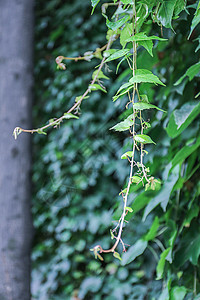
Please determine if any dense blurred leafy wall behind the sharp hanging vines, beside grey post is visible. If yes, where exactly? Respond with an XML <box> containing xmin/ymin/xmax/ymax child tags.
<box><xmin>32</xmin><ymin>0</ymin><xmax>200</xmax><ymax>300</ymax></box>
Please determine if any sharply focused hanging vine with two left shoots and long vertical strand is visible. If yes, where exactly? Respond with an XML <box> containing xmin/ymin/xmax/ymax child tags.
<box><xmin>13</xmin><ymin>0</ymin><xmax>169</xmax><ymax>260</ymax></box>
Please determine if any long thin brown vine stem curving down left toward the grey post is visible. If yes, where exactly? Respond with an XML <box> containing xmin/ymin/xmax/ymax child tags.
<box><xmin>14</xmin><ymin>34</ymin><xmax>115</xmax><ymax>133</ymax></box>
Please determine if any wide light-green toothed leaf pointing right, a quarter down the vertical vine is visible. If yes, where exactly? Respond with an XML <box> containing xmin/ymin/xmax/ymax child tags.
<box><xmin>129</xmin><ymin>69</ymin><xmax>165</xmax><ymax>86</ymax></box>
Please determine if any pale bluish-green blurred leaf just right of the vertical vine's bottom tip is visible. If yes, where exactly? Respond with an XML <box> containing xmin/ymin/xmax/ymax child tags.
<box><xmin>122</xmin><ymin>240</ymin><xmax>148</xmax><ymax>266</ymax></box>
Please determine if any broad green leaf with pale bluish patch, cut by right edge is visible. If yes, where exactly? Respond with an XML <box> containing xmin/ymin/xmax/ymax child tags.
<box><xmin>166</xmin><ymin>101</ymin><xmax>200</xmax><ymax>138</ymax></box>
